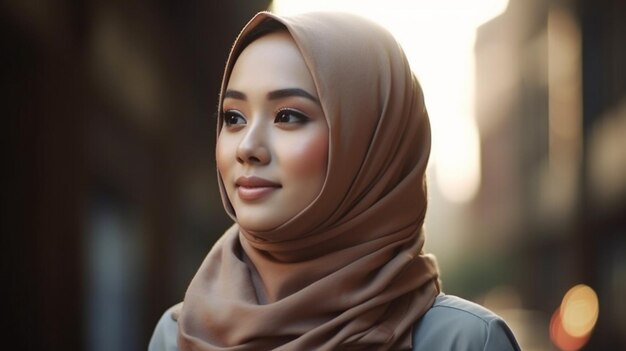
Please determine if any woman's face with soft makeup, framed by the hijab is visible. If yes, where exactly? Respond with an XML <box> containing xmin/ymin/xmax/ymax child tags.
<box><xmin>216</xmin><ymin>32</ymin><xmax>328</xmax><ymax>231</ymax></box>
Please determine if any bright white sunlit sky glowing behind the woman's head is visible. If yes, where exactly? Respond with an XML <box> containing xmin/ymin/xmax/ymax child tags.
<box><xmin>272</xmin><ymin>0</ymin><xmax>508</xmax><ymax>202</ymax></box>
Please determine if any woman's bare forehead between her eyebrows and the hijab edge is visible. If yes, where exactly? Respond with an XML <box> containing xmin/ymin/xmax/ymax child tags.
<box><xmin>228</xmin><ymin>31</ymin><xmax>317</xmax><ymax>95</ymax></box>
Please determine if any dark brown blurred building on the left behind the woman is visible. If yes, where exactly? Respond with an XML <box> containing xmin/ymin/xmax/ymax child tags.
<box><xmin>0</xmin><ymin>0</ymin><xmax>269</xmax><ymax>350</ymax></box>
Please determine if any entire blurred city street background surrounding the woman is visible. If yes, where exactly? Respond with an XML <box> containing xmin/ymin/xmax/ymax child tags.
<box><xmin>0</xmin><ymin>0</ymin><xmax>626</xmax><ymax>351</ymax></box>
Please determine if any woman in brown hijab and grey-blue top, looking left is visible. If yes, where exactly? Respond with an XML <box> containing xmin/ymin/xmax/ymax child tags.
<box><xmin>149</xmin><ymin>12</ymin><xmax>519</xmax><ymax>350</ymax></box>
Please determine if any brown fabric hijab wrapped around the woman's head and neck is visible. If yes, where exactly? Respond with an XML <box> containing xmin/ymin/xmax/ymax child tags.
<box><xmin>178</xmin><ymin>12</ymin><xmax>439</xmax><ymax>350</ymax></box>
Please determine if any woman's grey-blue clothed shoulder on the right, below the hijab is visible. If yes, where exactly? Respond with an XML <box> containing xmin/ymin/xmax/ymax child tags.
<box><xmin>413</xmin><ymin>295</ymin><xmax>520</xmax><ymax>351</ymax></box>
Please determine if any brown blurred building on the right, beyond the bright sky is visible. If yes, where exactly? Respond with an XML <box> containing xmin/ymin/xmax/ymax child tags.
<box><xmin>473</xmin><ymin>0</ymin><xmax>626</xmax><ymax>350</ymax></box>
